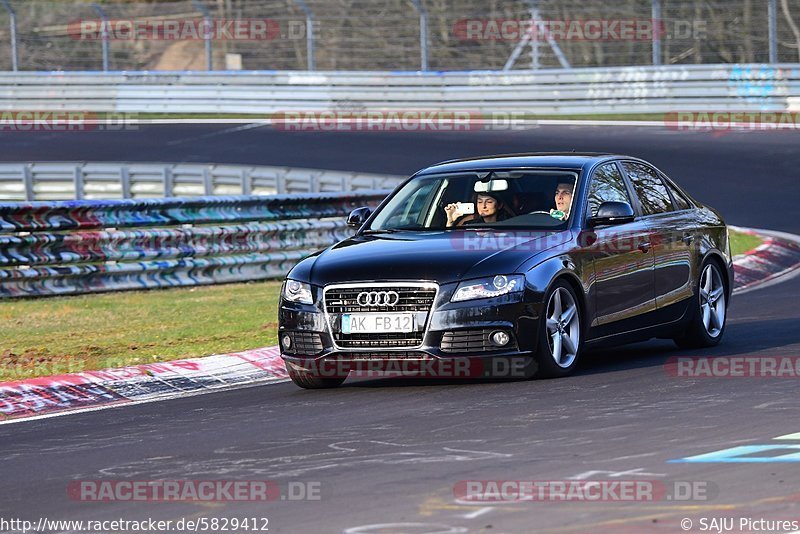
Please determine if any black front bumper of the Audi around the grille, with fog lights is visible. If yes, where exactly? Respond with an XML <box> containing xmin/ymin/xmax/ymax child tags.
<box><xmin>278</xmin><ymin>283</ymin><xmax>542</xmax><ymax>377</ymax></box>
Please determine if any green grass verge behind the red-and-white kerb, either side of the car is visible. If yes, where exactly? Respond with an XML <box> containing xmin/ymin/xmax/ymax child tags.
<box><xmin>0</xmin><ymin>228</ymin><xmax>761</xmax><ymax>381</ymax></box>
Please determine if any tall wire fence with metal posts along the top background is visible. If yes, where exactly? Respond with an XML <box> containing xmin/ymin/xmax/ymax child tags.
<box><xmin>0</xmin><ymin>0</ymin><xmax>800</xmax><ymax>71</ymax></box>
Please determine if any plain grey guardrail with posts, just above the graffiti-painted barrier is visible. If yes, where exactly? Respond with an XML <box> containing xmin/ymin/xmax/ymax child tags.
<box><xmin>0</xmin><ymin>162</ymin><xmax>405</xmax><ymax>200</ymax></box>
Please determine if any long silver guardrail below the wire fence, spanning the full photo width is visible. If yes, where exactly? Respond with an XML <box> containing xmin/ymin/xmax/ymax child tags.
<box><xmin>0</xmin><ymin>64</ymin><xmax>800</xmax><ymax>114</ymax></box>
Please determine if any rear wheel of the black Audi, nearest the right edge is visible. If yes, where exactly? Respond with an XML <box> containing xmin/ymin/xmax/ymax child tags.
<box><xmin>674</xmin><ymin>261</ymin><xmax>728</xmax><ymax>349</ymax></box>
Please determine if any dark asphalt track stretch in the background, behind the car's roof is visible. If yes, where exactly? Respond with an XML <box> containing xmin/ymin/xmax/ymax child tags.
<box><xmin>0</xmin><ymin>125</ymin><xmax>800</xmax><ymax>234</ymax></box>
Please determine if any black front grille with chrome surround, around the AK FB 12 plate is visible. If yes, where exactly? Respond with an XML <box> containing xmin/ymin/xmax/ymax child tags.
<box><xmin>325</xmin><ymin>284</ymin><xmax>436</xmax><ymax>350</ymax></box>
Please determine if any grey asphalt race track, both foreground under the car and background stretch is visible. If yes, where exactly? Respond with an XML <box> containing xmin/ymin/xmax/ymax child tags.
<box><xmin>0</xmin><ymin>125</ymin><xmax>800</xmax><ymax>533</ymax></box>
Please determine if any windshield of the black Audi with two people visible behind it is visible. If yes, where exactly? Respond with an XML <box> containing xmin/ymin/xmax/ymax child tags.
<box><xmin>367</xmin><ymin>170</ymin><xmax>578</xmax><ymax>232</ymax></box>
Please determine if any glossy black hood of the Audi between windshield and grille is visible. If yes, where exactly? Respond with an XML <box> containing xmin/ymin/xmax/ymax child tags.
<box><xmin>290</xmin><ymin>231</ymin><xmax>571</xmax><ymax>285</ymax></box>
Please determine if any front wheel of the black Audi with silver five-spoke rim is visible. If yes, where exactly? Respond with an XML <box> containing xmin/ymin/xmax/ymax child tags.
<box><xmin>534</xmin><ymin>280</ymin><xmax>583</xmax><ymax>378</ymax></box>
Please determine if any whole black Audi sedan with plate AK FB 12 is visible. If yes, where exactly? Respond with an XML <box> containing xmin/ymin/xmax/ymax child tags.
<box><xmin>278</xmin><ymin>153</ymin><xmax>733</xmax><ymax>388</ymax></box>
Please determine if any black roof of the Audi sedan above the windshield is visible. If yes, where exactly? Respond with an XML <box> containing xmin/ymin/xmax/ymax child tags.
<box><xmin>417</xmin><ymin>152</ymin><xmax>636</xmax><ymax>175</ymax></box>
